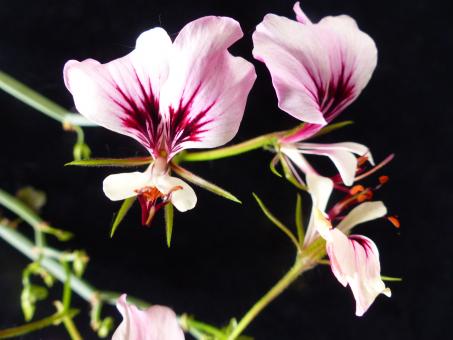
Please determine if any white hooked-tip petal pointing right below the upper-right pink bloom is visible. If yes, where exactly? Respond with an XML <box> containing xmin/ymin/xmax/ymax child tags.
<box><xmin>296</xmin><ymin>142</ymin><xmax>373</xmax><ymax>185</ymax></box>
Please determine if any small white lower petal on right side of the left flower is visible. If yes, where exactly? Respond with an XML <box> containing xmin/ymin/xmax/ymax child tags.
<box><xmin>156</xmin><ymin>175</ymin><xmax>197</xmax><ymax>212</ymax></box>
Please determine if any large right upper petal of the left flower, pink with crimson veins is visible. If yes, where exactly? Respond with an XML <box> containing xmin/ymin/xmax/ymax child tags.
<box><xmin>161</xmin><ymin>16</ymin><xmax>256</xmax><ymax>154</ymax></box>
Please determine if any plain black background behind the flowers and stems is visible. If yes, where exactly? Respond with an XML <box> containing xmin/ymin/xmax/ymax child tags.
<box><xmin>0</xmin><ymin>0</ymin><xmax>446</xmax><ymax>339</ymax></box>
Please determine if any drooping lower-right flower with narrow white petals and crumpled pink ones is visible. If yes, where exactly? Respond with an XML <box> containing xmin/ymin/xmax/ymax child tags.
<box><xmin>304</xmin><ymin>174</ymin><xmax>391</xmax><ymax>316</ymax></box>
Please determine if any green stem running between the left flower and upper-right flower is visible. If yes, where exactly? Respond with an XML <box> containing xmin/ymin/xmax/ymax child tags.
<box><xmin>178</xmin><ymin>132</ymin><xmax>284</xmax><ymax>162</ymax></box>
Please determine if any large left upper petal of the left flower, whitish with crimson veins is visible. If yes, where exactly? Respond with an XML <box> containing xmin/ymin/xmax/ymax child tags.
<box><xmin>63</xmin><ymin>28</ymin><xmax>171</xmax><ymax>150</ymax></box>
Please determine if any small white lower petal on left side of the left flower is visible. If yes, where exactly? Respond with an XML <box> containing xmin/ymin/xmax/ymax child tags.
<box><xmin>103</xmin><ymin>171</ymin><xmax>152</xmax><ymax>201</ymax></box>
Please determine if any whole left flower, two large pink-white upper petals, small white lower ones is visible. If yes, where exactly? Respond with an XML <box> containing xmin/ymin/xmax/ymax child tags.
<box><xmin>64</xmin><ymin>16</ymin><xmax>256</xmax><ymax>224</ymax></box>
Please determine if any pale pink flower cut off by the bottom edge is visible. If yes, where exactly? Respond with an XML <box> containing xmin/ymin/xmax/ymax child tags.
<box><xmin>112</xmin><ymin>294</ymin><xmax>184</xmax><ymax>340</ymax></box>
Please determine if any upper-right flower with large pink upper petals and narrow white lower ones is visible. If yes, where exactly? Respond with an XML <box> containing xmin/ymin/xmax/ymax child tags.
<box><xmin>253</xmin><ymin>2</ymin><xmax>377</xmax><ymax>185</ymax></box>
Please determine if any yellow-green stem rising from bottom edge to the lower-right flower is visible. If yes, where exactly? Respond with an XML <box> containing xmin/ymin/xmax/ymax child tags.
<box><xmin>228</xmin><ymin>260</ymin><xmax>305</xmax><ymax>340</ymax></box>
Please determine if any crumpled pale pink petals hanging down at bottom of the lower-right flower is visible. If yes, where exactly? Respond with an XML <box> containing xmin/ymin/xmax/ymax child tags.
<box><xmin>327</xmin><ymin>229</ymin><xmax>391</xmax><ymax>316</ymax></box>
